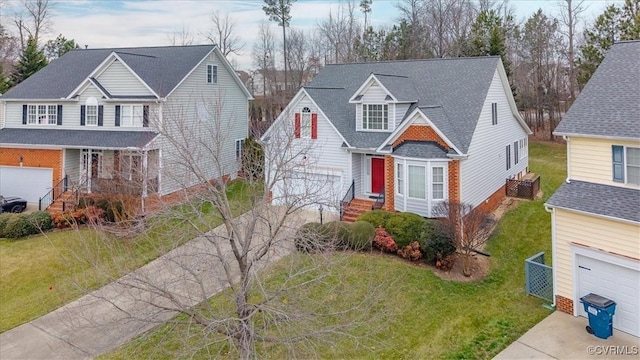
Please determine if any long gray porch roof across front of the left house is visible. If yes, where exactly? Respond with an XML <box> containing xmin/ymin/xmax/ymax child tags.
<box><xmin>0</xmin><ymin>128</ymin><xmax>158</xmax><ymax>149</ymax></box>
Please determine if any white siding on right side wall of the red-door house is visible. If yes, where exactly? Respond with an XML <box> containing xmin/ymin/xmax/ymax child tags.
<box><xmin>460</xmin><ymin>70</ymin><xmax>529</xmax><ymax>206</ymax></box>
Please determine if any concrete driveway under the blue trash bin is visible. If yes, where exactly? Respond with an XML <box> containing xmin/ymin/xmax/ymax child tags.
<box><xmin>494</xmin><ymin>311</ymin><xmax>640</xmax><ymax>360</ymax></box>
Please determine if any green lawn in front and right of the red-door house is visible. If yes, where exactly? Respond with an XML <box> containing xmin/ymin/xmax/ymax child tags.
<box><xmin>103</xmin><ymin>143</ymin><xmax>566</xmax><ymax>359</ymax></box>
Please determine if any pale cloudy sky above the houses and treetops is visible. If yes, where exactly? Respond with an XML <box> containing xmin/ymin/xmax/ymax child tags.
<box><xmin>0</xmin><ymin>0</ymin><xmax>620</xmax><ymax>69</ymax></box>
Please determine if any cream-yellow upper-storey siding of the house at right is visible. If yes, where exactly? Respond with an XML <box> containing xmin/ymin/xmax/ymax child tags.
<box><xmin>567</xmin><ymin>137</ymin><xmax>640</xmax><ymax>188</ymax></box>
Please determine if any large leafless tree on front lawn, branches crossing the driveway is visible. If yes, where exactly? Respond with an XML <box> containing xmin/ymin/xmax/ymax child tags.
<box><xmin>61</xmin><ymin>94</ymin><xmax>389</xmax><ymax>359</ymax></box>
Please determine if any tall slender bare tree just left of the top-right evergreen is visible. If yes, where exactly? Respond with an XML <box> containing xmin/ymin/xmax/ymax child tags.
<box><xmin>559</xmin><ymin>0</ymin><xmax>588</xmax><ymax>101</ymax></box>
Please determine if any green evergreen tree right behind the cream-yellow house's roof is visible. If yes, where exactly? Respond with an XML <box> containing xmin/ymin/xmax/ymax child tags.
<box><xmin>576</xmin><ymin>0</ymin><xmax>640</xmax><ymax>88</ymax></box>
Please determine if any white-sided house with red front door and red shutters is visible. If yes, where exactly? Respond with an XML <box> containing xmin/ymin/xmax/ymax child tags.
<box><xmin>262</xmin><ymin>57</ymin><xmax>531</xmax><ymax>220</ymax></box>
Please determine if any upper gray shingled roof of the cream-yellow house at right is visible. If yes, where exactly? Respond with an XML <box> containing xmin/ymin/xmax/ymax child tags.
<box><xmin>554</xmin><ymin>40</ymin><xmax>640</xmax><ymax>139</ymax></box>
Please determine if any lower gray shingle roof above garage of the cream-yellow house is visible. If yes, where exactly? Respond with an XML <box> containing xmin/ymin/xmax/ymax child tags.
<box><xmin>546</xmin><ymin>180</ymin><xmax>640</xmax><ymax>223</ymax></box>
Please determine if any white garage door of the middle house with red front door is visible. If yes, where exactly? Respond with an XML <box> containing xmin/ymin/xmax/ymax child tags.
<box><xmin>273</xmin><ymin>172</ymin><xmax>344</xmax><ymax>211</ymax></box>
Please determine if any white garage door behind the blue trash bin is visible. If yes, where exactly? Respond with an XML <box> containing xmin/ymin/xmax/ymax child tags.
<box><xmin>577</xmin><ymin>255</ymin><xmax>640</xmax><ymax>336</ymax></box>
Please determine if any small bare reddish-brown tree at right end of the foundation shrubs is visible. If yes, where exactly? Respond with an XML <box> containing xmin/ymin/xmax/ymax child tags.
<box><xmin>435</xmin><ymin>201</ymin><xmax>496</xmax><ymax>276</ymax></box>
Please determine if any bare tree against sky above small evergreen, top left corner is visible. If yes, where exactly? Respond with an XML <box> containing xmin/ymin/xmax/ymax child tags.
<box><xmin>14</xmin><ymin>0</ymin><xmax>52</xmax><ymax>50</ymax></box>
